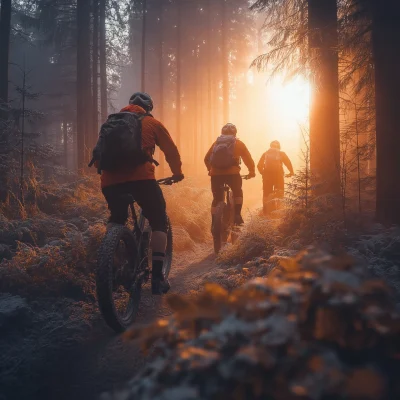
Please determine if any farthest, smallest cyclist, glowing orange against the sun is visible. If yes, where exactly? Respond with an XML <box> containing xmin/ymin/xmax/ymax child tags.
<box><xmin>257</xmin><ymin>140</ymin><xmax>294</xmax><ymax>212</ymax></box>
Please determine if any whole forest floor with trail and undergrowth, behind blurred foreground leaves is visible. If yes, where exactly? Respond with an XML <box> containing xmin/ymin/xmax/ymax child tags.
<box><xmin>0</xmin><ymin>178</ymin><xmax>400</xmax><ymax>400</ymax></box>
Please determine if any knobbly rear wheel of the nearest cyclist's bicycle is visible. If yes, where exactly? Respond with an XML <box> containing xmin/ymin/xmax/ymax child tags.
<box><xmin>96</xmin><ymin>225</ymin><xmax>141</xmax><ymax>333</ymax></box>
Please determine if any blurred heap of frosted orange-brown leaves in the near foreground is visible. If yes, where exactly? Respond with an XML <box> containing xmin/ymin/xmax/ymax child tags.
<box><xmin>104</xmin><ymin>249</ymin><xmax>400</xmax><ymax>400</ymax></box>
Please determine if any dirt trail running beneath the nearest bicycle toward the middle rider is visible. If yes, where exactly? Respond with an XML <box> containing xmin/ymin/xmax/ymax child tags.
<box><xmin>35</xmin><ymin>245</ymin><xmax>215</xmax><ymax>400</ymax></box>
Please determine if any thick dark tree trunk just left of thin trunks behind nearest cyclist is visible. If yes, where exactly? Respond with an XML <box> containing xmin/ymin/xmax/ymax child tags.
<box><xmin>76</xmin><ymin>0</ymin><xmax>91</xmax><ymax>171</ymax></box>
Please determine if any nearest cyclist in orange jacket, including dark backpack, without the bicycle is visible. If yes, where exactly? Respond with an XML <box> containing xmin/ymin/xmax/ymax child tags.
<box><xmin>93</xmin><ymin>92</ymin><xmax>184</xmax><ymax>294</ymax></box>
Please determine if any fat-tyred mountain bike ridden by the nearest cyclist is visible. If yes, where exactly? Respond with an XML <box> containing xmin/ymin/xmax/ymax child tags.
<box><xmin>96</xmin><ymin>178</ymin><xmax>175</xmax><ymax>333</ymax></box>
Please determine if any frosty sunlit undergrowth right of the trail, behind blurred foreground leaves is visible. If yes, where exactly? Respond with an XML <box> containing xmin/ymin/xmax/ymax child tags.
<box><xmin>209</xmin><ymin>205</ymin><xmax>400</xmax><ymax>301</ymax></box>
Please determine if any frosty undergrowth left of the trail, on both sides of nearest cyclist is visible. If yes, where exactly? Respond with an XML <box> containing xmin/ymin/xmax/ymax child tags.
<box><xmin>0</xmin><ymin>176</ymin><xmax>210</xmax><ymax>400</ymax></box>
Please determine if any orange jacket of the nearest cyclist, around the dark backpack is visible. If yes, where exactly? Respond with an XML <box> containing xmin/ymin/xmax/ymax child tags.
<box><xmin>101</xmin><ymin>105</ymin><xmax>182</xmax><ymax>188</ymax></box>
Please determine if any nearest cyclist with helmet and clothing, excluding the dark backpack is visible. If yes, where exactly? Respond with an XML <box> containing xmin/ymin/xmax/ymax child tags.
<box><xmin>97</xmin><ymin>92</ymin><xmax>184</xmax><ymax>294</ymax></box>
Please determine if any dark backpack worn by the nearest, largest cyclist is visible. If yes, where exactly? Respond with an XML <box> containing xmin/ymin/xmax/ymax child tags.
<box><xmin>91</xmin><ymin>112</ymin><xmax>153</xmax><ymax>172</ymax></box>
